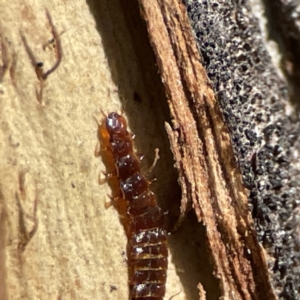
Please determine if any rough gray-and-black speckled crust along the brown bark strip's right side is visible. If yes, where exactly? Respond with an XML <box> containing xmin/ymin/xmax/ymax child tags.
<box><xmin>185</xmin><ymin>0</ymin><xmax>300</xmax><ymax>299</ymax></box>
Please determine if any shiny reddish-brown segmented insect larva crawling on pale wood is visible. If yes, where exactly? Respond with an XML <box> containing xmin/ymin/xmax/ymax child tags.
<box><xmin>98</xmin><ymin>112</ymin><xmax>168</xmax><ymax>300</ymax></box>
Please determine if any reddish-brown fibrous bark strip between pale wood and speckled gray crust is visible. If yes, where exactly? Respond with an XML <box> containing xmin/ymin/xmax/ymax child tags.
<box><xmin>139</xmin><ymin>0</ymin><xmax>276</xmax><ymax>299</ymax></box>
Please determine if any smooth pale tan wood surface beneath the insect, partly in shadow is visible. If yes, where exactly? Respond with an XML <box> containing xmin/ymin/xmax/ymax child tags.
<box><xmin>0</xmin><ymin>0</ymin><xmax>195</xmax><ymax>300</ymax></box>
